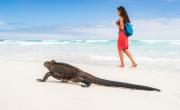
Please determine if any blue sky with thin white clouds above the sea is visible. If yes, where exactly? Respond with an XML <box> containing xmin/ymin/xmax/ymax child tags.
<box><xmin>0</xmin><ymin>0</ymin><xmax>180</xmax><ymax>40</ymax></box>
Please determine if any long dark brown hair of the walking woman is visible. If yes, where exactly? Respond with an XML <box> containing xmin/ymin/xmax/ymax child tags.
<box><xmin>117</xmin><ymin>6</ymin><xmax>130</xmax><ymax>23</ymax></box>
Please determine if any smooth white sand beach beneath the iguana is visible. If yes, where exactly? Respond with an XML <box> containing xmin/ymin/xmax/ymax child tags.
<box><xmin>0</xmin><ymin>59</ymin><xmax>180</xmax><ymax>110</ymax></box>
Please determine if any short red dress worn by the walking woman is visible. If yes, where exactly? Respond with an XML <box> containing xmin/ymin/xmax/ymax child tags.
<box><xmin>117</xmin><ymin>25</ymin><xmax>129</xmax><ymax>49</ymax></box>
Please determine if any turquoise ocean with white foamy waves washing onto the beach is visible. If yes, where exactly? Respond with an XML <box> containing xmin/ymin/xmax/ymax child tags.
<box><xmin>0</xmin><ymin>40</ymin><xmax>180</xmax><ymax>74</ymax></box>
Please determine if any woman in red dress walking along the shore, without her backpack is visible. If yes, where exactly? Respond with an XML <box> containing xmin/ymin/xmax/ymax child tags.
<box><xmin>116</xmin><ymin>6</ymin><xmax>137</xmax><ymax>68</ymax></box>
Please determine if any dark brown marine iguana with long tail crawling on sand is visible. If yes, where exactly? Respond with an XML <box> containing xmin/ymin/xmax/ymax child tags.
<box><xmin>37</xmin><ymin>60</ymin><xmax>160</xmax><ymax>92</ymax></box>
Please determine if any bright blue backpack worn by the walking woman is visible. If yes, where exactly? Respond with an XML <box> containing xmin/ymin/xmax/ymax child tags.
<box><xmin>118</xmin><ymin>22</ymin><xmax>133</xmax><ymax>37</ymax></box>
